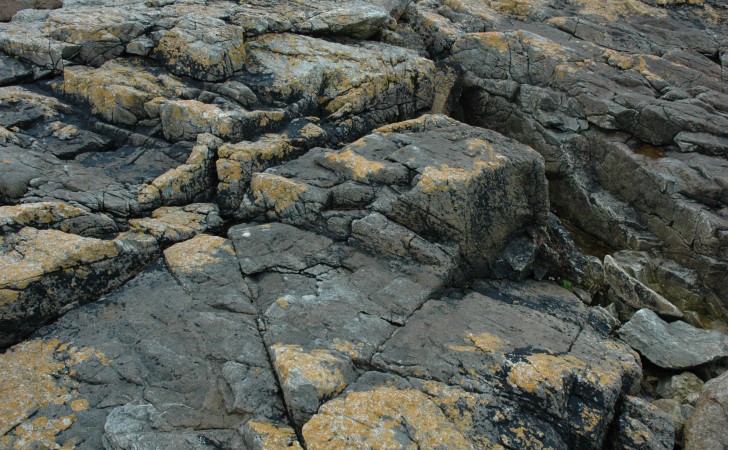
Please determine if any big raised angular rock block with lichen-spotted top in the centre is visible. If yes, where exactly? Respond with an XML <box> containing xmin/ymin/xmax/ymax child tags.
<box><xmin>237</xmin><ymin>115</ymin><xmax>548</xmax><ymax>274</ymax></box>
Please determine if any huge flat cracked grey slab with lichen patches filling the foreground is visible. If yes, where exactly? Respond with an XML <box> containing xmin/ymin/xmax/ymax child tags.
<box><xmin>0</xmin><ymin>223</ymin><xmax>641</xmax><ymax>449</ymax></box>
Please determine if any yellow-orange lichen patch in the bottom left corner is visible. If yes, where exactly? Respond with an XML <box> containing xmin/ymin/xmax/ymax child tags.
<box><xmin>0</xmin><ymin>339</ymin><xmax>109</xmax><ymax>448</ymax></box>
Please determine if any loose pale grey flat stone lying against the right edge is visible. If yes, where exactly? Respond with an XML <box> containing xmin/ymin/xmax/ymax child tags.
<box><xmin>618</xmin><ymin>309</ymin><xmax>727</xmax><ymax>370</ymax></box>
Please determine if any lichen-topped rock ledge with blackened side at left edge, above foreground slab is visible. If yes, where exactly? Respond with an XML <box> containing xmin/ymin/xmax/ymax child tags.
<box><xmin>0</xmin><ymin>228</ymin><xmax>159</xmax><ymax>346</ymax></box>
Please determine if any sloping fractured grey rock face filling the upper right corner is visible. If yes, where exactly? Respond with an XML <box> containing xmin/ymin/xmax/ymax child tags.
<box><xmin>407</xmin><ymin>0</ymin><xmax>727</xmax><ymax>306</ymax></box>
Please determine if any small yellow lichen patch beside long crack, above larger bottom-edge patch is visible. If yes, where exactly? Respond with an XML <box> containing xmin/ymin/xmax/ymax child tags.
<box><xmin>271</xmin><ymin>344</ymin><xmax>347</xmax><ymax>398</ymax></box>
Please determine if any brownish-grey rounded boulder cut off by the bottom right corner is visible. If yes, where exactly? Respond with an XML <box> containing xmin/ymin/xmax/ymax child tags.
<box><xmin>684</xmin><ymin>373</ymin><xmax>727</xmax><ymax>450</ymax></box>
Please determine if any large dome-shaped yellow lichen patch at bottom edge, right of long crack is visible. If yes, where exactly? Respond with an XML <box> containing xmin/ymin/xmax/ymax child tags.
<box><xmin>302</xmin><ymin>386</ymin><xmax>474</xmax><ymax>450</ymax></box>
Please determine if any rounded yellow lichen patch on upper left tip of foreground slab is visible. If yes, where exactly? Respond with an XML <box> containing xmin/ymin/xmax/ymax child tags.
<box><xmin>164</xmin><ymin>234</ymin><xmax>235</xmax><ymax>273</ymax></box>
